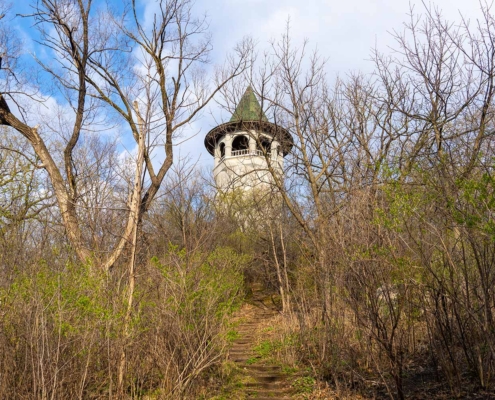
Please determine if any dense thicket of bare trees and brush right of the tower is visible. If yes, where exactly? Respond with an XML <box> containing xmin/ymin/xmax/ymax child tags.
<box><xmin>215</xmin><ymin>5</ymin><xmax>495</xmax><ymax>398</ymax></box>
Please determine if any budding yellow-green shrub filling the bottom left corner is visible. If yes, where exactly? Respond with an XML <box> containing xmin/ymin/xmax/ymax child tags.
<box><xmin>0</xmin><ymin>261</ymin><xmax>123</xmax><ymax>398</ymax></box>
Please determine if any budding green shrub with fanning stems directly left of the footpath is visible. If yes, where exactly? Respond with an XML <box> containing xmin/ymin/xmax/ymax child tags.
<box><xmin>147</xmin><ymin>245</ymin><xmax>250</xmax><ymax>397</ymax></box>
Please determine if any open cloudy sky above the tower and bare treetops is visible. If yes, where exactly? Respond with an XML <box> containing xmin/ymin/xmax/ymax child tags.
<box><xmin>7</xmin><ymin>0</ymin><xmax>488</xmax><ymax>168</ymax></box>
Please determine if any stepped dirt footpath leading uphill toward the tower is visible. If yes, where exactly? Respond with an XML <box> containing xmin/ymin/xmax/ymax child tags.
<box><xmin>229</xmin><ymin>288</ymin><xmax>295</xmax><ymax>400</ymax></box>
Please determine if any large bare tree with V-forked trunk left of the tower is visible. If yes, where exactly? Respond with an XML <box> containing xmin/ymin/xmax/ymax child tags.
<box><xmin>0</xmin><ymin>0</ymin><xmax>250</xmax><ymax>269</ymax></box>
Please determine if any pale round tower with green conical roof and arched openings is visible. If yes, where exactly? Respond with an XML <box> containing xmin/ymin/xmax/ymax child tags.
<box><xmin>205</xmin><ymin>86</ymin><xmax>293</xmax><ymax>192</ymax></box>
